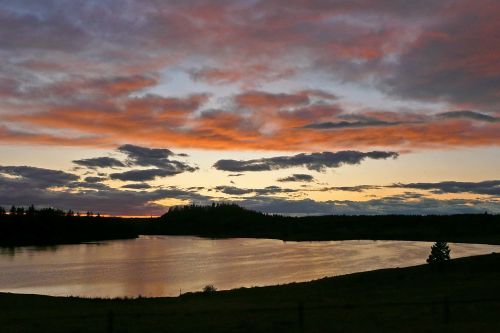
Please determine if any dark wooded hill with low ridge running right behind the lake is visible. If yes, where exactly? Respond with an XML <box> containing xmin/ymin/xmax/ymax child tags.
<box><xmin>153</xmin><ymin>204</ymin><xmax>500</xmax><ymax>244</ymax></box>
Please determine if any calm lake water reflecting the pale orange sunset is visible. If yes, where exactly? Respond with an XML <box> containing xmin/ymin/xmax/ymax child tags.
<box><xmin>0</xmin><ymin>236</ymin><xmax>500</xmax><ymax>297</ymax></box>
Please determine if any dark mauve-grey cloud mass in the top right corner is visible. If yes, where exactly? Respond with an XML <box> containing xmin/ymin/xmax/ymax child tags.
<box><xmin>380</xmin><ymin>2</ymin><xmax>500</xmax><ymax>108</ymax></box>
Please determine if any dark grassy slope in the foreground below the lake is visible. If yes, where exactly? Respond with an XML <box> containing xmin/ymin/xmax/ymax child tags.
<box><xmin>0</xmin><ymin>254</ymin><xmax>500</xmax><ymax>333</ymax></box>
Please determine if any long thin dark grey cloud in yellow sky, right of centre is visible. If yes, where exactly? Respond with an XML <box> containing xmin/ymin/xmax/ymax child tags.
<box><xmin>214</xmin><ymin>150</ymin><xmax>399</xmax><ymax>172</ymax></box>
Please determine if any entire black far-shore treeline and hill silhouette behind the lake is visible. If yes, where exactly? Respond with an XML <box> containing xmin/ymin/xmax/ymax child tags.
<box><xmin>0</xmin><ymin>204</ymin><xmax>500</xmax><ymax>246</ymax></box>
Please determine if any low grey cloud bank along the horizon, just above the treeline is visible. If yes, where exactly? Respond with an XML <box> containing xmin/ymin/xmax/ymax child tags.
<box><xmin>0</xmin><ymin>167</ymin><xmax>500</xmax><ymax>215</ymax></box>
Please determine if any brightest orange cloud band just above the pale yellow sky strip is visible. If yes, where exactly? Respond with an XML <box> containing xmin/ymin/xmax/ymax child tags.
<box><xmin>4</xmin><ymin>93</ymin><xmax>500</xmax><ymax>151</ymax></box>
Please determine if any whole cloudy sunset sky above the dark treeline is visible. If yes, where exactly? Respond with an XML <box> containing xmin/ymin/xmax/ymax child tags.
<box><xmin>0</xmin><ymin>0</ymin><xmax>500</xmax><ymax>216</ymax></box>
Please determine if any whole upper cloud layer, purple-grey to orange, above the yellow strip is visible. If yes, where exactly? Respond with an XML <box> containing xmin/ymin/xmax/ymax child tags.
<box><xmin>0</xmin><ymin>0</ymin><xmax>500</xmax><ymax>151</ymax></box>
